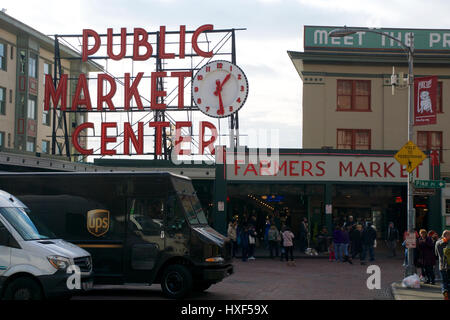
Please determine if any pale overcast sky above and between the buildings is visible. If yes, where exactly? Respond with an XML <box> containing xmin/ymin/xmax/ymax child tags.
<box><xmin>0</xmin><ymin>0</ymin><xmax>450</xmax><ymax>155</ymax></box>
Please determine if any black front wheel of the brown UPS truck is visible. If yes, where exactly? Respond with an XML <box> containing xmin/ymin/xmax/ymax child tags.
<box><xmin>161</xmin><ymin>264</ymin><xmax>192</xmax><ymax>299</ymax></box>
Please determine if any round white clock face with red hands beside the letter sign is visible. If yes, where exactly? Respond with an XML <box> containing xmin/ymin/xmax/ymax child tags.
<box><xmin>192</xmin><ymin>60</ymin><xmax>248</xmax><ymax>118</ymax></box>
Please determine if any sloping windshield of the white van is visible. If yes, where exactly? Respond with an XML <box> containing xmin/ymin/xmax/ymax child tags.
<box><xmin>0</xmin><ymin>207</ymin><xmax>56</xmax><ymax>241</ymax></box>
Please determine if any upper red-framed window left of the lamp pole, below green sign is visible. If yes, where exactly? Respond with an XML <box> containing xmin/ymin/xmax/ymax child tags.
<box><xmin>337</xmin><ymin>80</ymin><xmax>370</xmax><ymax>111</ymax></box>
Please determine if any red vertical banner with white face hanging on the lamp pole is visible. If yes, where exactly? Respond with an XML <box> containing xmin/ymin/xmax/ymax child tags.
<box><xmin>414</xmin><ymin>76</ymin><xmax>437</xmax><ymax>126</ymax></box>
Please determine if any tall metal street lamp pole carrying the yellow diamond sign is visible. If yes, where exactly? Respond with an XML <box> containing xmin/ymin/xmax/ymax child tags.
<box><xmin>405</xmin><ymin>33</ymin><xmax>416</xmax><ymax>276</ymax></box>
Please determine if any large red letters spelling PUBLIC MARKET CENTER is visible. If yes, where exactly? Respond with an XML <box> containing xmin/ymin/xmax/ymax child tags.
<box><xmin>44</xmin><ymin>24</ymin><xmax>225</xmax><ymax>155</ymax></box>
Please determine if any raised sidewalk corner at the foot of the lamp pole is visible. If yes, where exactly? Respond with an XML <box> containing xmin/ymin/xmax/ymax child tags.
<box><xmin>391</xmin><ymin>281</ymin><xmax>443</xmax><ymax>300</ymax></box>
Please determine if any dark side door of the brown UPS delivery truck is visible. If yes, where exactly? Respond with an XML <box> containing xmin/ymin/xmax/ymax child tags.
<box><xmin>125</xmin><ymin>198</ymin><xmax>165</xmax><ymax>282</ymax></box>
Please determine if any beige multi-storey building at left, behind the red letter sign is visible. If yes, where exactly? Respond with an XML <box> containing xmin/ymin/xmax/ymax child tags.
<box><xmin>0</xmin><ymin>12</ymin><xmax>100</xmax><ymax>161</ymax></box>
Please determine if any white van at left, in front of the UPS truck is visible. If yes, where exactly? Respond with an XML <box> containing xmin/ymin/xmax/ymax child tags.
<box><xmin>0</xmin><ymin>190</ymin><xmax>92</xmax><ymax>300</ymax></box>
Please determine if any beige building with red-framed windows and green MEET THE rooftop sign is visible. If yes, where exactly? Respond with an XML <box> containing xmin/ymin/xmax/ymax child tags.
<box><xmin>288</xmin><ymin>26</ymin><xmax>450</xmax><ymax>177</ymax></box>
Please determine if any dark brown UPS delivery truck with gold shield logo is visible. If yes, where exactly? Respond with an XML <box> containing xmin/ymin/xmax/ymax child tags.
<box><xmin>0</xmin><ymin>172</ymin><xmax>233</xmax><ymax>298</ymax></box>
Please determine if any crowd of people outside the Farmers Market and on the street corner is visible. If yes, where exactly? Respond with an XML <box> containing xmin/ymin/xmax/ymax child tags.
<box><xmin>228</xmin><ymin>215</ymin><xmax>450</xmax><ymax>299</ymax></box>
